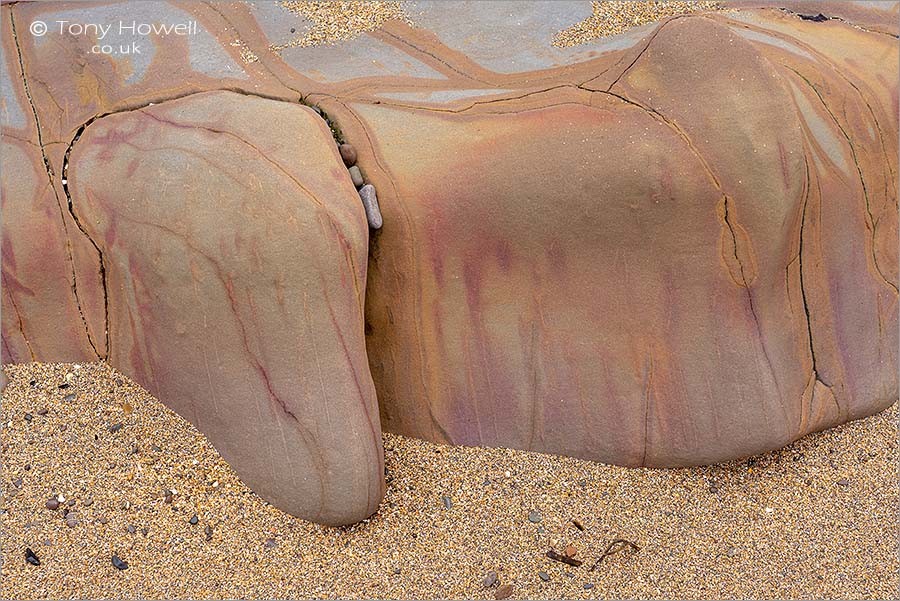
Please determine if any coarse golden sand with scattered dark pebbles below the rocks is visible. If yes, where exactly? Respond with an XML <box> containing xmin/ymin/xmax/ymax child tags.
<box><xmin>0</xmin><ymin>363</ymin><xmax>898</xmax><ymax>599</ymax></box>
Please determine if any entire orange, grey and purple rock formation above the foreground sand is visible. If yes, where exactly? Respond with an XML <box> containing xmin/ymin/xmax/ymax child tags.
<box><xmin>0</xmin><ymin>1</ymin><xmax>898</xmax><ymax>524</ymax></box>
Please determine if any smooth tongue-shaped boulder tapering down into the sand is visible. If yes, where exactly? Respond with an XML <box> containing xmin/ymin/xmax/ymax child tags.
<box><xmin>70</xmin><ymin>92</ymin><xmax>384</xmax><ymax>525</ymax></box>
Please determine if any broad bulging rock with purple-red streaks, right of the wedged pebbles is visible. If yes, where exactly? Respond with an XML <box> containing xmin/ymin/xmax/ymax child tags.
<box><xmin>360</xmin><ymin>12</ymin><xmax>897</xmax><ymax>467</ymax></box>
